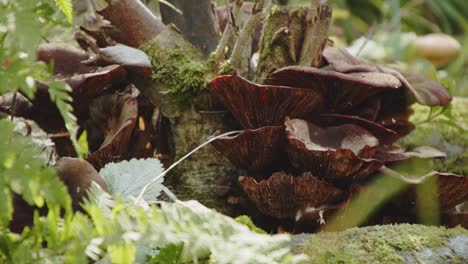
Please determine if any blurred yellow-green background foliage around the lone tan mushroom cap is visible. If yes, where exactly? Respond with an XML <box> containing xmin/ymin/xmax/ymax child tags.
<box><xmin>217</xmin><ymin>0</ymin><xmax>468</xmax><ymax>96</ymax></box>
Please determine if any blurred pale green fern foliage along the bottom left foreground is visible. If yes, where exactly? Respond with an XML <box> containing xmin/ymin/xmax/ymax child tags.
<box><xmin>0</xmin><ymin>151</ymin><xmax>304</xmax><ymax>263</ymax></box>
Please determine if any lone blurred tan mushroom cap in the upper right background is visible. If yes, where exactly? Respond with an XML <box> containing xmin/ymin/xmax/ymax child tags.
<box><xmin>412</xmin><ymin>33</ymin><xmax>461</xmax><ymax>65</ymax></box>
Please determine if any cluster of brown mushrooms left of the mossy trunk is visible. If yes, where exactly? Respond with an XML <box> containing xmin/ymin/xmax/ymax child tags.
<box><xmin>0</xmin><ymin>43</ymin><xmax>172</xmax><ymax>170</ymax></box>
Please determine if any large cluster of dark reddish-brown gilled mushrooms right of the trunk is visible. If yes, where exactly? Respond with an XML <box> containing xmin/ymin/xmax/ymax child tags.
<box><xmin>210</xmin><ymin>47</ymin><xmax>468</xmax><ymax>231</ymax></box>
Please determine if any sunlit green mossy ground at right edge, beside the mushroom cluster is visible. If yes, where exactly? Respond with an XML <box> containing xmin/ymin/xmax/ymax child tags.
<box><xmin>398</xmin><ymin>98</ymin><xmax>468</xmax><ymax>176</ymax></box>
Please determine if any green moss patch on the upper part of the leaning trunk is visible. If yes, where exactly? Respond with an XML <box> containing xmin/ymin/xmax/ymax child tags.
<box><xmin>140</xmin><ymin>26</ymin><xmax>210</xmax><ymax>104</ymax></box>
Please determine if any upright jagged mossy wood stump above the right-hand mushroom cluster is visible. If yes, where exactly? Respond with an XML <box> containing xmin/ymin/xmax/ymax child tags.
<box><xmin>256</xmin><ymin>0</ymin><xmax>332</xmax><ymax>83</ymax></box>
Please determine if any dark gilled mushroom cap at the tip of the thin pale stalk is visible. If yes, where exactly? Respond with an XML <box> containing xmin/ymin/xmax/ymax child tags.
<box><xmin>212</xmin><ymin>126</ymin><xmax>285</xmax><ymax>175</ymax></box>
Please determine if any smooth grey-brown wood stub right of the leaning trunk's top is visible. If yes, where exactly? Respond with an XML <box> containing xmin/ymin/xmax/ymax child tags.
<box><xmin>159</xmin><ymin>0</ymin><xmax>219</xmax><ymax>57</ymax></box>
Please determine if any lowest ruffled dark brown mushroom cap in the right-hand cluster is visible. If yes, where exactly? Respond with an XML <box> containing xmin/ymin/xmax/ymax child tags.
<box><xmin>239</xmin><ymin>172</ymin><xmax>343</xmax><ymax>219</ymax></box>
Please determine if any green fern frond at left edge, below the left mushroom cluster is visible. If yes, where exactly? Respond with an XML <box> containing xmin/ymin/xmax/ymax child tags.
<box><xmin>0</xmin><ymin>119</ymin><xmax>71</xmax><ymax>229</ymax></box>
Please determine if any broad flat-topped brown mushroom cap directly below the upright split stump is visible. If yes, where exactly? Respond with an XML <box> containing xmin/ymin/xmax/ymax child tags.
<box><xmin>267</xmin><ymin>66</ymin><xmax>401</xmax><ymax>113</ymax></box>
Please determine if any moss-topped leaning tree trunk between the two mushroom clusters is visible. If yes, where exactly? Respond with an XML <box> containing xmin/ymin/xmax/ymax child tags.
<box><xmin>136</xmin><ymin>27</ymin><xmax>236</xmax><ymax>214</ymax></box>
